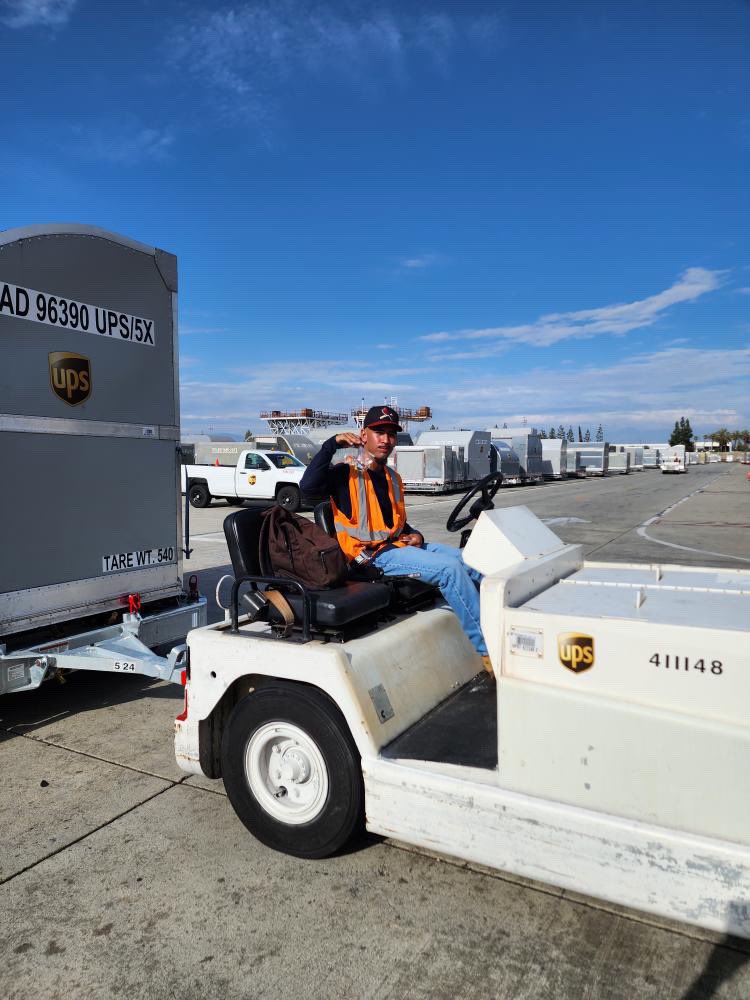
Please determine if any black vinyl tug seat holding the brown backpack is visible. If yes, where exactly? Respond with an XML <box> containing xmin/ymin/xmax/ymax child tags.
<box><xmin>224</xmin><ymin>507</ymin><xmax>391</xmax><ymax>631</ymax></box>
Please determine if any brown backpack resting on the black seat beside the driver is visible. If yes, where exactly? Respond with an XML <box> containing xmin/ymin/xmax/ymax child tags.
<box><xmin>259</xmin><ymin>507</ymin><xmax>348</xmax><ymax>590</ymax></box>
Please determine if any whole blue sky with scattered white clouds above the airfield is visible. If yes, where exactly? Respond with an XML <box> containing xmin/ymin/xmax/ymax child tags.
<box><xmin>0</xmin><ymin>0</ymin><xmax>750</xmax><ymax>440</ymax></box>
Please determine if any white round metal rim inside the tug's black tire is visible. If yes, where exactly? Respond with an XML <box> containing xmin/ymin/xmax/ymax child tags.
<box><xmin>245</xmin><ymin>722</ymin><xmax>329</xmax><ymax>826</ymax></box>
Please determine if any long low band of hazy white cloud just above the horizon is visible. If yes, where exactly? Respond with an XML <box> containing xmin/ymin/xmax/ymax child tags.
<box><xmin>181</xmin><ymin>347</ymin><xmax>750</xmax><ymax>440</ymax></box>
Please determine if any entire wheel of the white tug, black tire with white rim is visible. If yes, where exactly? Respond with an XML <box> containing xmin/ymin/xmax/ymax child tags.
<box><xmin>221</xmin><ymin>684</ymin><xmax>364</xmax><ymax>858</ymax></box>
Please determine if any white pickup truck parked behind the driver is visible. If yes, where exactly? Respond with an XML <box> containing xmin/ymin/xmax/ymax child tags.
<box><xmin>182</xmin><ymin>449</ymin><xmax>305</xmax><ymax>511</ymax></box>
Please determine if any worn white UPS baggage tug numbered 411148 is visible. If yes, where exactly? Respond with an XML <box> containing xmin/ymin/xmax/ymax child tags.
<box><xmin>176</xmin><ymin>476</ymin><xmax>750</xmax><ymax>937</ymax></box>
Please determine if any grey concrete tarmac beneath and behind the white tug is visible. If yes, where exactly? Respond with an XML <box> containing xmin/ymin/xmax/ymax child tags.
<box><xmin>0</xmin><ymin>465</ymin><xmax>750</xmax><ymax>1000</ymax></box>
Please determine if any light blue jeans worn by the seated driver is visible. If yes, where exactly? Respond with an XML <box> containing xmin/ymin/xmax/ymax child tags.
<box><xmin>373</xmin><ymin>542</ymin><xmax>487</xmax><ymax>656</ymax></box>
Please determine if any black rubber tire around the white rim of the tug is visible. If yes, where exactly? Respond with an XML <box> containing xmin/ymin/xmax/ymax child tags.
<box><xmin>221</xmin><ymin>683</ymin><xmax>364</xmax><ymax>858</ymax></box>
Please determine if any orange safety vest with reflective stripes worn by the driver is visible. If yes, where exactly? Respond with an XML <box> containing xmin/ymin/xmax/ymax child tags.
<box><xmin>331</xmin><ymin>465</ymin><xmax>406</xmax><ymax>562</ymax></box>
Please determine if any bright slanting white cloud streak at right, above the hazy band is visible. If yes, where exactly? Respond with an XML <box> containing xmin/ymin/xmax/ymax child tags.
<box><xmin>419</xmin><ymin>267</ymin><xmax>726</xmax><ymax>361</ymax></box>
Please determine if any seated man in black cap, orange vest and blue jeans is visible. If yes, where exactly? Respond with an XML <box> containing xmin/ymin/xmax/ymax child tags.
<box><xmin>300</xmin><ymin>406</ymin><xmax>492</xmax><ymax>672</ymax></box>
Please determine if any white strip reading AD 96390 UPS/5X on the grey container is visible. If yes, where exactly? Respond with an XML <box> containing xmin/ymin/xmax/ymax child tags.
<box><xmin>0</xmin><ymin>281</ymin><xmax>156</xmax><ymax>347</ymax></box>
